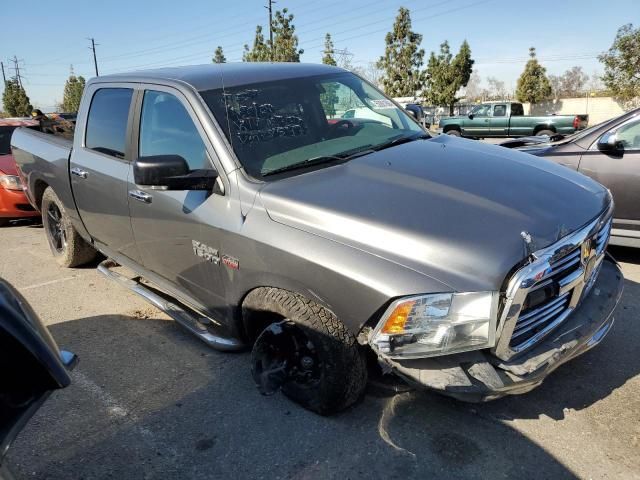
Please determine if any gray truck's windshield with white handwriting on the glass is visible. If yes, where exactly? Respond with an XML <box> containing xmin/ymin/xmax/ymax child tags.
<box><xmin>201</xmin><ymin>72</ymin><xmax>424</xmax><ymax>178</ymax></box>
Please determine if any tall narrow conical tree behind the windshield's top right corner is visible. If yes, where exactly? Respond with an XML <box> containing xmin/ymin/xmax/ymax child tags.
<box><xmin>377</xmin><ymin>7</ymin><xmax>424</xmax><ymax>97</ymax></box>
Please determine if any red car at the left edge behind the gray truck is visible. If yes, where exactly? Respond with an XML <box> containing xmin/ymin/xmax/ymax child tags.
<box><xmin>0</xmin><ymin>119</ymin><xmax>40</xmax><ymax>227</ymax></box>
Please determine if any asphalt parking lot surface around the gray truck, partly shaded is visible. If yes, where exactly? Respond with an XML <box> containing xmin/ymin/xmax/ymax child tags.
<box><xmin>0</xmin><ymin>223</ymin><xmax>640</xmax><ymax>479</ymax></box>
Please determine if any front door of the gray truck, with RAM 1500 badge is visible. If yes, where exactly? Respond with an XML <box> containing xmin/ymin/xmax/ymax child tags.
<box><xmin>128</xmin><ymin>86</ymin><xmax>234</xmax><ymax>311</ymax></box>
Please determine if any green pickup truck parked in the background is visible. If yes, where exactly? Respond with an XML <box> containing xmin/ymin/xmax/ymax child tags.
<box><xmin>440</xmin><ymin>102</ymin><xmax>589</xmax><ymax>138</ymax></box>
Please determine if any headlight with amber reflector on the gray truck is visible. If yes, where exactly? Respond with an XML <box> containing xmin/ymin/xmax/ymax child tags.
<box><xmin>370</xmin><ymin>292</ymin><xmax>498</xmax><ymax>358</ymax></box>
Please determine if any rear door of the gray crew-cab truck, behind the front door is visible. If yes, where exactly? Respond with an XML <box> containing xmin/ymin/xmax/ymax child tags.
<box><xmin>70</xmin><ymin>84</ymin><xmax>139</xmax><ymax>261</ymax></box>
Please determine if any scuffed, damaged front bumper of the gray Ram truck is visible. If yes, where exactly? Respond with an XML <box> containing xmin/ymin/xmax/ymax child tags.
<box><xmin>379</xmin><ymin>257</ymin><xmax>624</xmax><ymax>402</ymax></box>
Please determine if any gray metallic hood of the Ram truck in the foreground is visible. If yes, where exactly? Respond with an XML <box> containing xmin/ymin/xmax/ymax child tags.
<box><xmin>260</xmin><ymin>135</ymin><xmax>610</xmax><ymax>291</ymax></box>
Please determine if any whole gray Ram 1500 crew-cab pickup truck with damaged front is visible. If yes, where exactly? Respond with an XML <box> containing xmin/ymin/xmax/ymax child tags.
<box><xmin>12</xmin><ymin>63</ymin><xmax>623</xmax><ymax>414</ymax></box>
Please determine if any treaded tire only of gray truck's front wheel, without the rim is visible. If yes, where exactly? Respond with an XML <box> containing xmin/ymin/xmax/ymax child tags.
<box><xmin>243</xmin><ymin>288</ymin><xmax>367</xmax><ymax>415</ymax></box>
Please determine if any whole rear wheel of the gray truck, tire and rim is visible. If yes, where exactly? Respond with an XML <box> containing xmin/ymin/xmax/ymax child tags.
<box><xmin>40</xmin><ymin>187</ymin><xmax>96</xmax><ymax>267</ymax></box>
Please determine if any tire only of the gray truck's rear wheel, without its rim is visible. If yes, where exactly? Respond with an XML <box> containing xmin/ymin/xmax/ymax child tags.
<box><xmin>40</xmin><ymin>187</ymin><xmax>97</xmax><ymax>268</ymax></box>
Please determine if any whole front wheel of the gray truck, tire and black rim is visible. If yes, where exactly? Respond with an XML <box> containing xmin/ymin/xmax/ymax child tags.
<box><xmin>243</xmin><ymin>288</ymin><xmax>367</xmax><ymax>415</ymax></box>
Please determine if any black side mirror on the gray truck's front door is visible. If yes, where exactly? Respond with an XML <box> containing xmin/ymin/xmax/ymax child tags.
<box><xmin>133</xmin><ymin>155</ymin><xmax>218</xmax><ymax>190</ymax></box>
